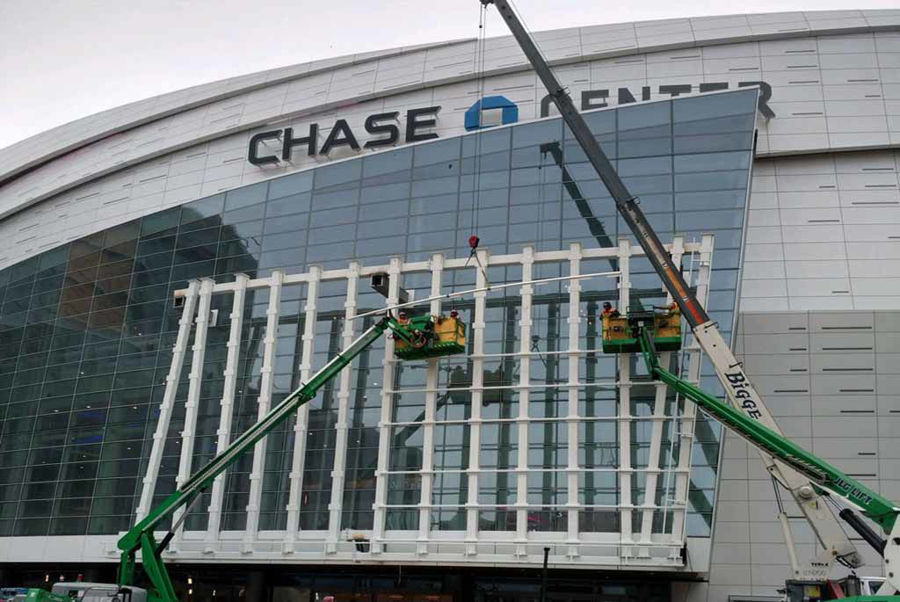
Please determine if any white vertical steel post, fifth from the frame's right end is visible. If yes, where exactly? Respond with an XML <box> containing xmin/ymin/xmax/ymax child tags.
<box><xmin>516</xmin><ymin>247</ymin><xmax>534</xmax><ymax>558</ymax></box>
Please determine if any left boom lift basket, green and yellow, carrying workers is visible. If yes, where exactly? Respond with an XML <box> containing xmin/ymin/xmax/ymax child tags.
<box><xmin>394</xmin><ymin>312</ymin><xmax>466</xmax><ymax>360</ymax></box>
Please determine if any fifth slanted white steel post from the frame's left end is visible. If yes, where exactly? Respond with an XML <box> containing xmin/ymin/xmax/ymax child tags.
<box><xmin>283</xmin><ymin>266</ymin><xmax>322</xmax><ymax>554</ymax></box>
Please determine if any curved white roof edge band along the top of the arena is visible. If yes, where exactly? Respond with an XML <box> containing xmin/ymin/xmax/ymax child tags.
<box><xmin>0</xmin><ymin>9</ymin><xmax>900</xmax><ymax>186</ymax></box>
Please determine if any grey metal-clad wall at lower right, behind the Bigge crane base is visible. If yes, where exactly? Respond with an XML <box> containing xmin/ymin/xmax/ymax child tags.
<box><xmin>689</xmin><ymin>305</ymin><xmax>900</xmax><ymax>602</ymax></box>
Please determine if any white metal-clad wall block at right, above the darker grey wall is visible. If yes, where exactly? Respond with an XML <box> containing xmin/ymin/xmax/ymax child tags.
<box><xmin>741</xmin><ymin>150</ymin><xmax>900</xmax><ymax>311</ymax></box>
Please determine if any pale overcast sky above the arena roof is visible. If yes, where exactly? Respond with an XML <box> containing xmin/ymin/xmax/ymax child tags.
<box><xmin>0</xmin><ymin>0</ymin><xmax>897</xmax><ymax>148</ymax></box>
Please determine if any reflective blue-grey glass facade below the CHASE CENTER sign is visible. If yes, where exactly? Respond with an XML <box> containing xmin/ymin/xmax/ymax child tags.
<box><xmin>0</xmin><ymin>90</ymin><xmax>757</xmax><ymax>536</ymax></box>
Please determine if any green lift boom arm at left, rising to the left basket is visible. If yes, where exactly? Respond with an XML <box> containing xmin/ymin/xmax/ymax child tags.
<box><xmin>118</xmin><ymin>316</ymin><xmax>400</xmax><ymax>602</ymax></box>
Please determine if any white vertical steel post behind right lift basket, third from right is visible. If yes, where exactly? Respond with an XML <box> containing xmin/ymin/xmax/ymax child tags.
<box><xmin>618</xmin><ymin>238</ymin><xmax>633</xmax><ymax>557</ymax></box>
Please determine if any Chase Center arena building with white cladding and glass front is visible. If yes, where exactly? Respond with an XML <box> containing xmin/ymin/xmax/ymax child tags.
<box><xmin>0</xmin><ymin>10</ymin><xmax>900</xmax><ymax>601</ymax></box>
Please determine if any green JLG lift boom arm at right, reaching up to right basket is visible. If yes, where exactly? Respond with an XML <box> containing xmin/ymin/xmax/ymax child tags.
<box><xmin>640</xmin><ymin>329</ymin><xmax>900</xmax><ymax>534</ymax></box>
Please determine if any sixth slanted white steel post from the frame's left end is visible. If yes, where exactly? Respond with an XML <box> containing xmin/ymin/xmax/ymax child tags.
<box><xmin>325</xmin><ymin>261</ymin><xmax>359</xmax><ymax>554</ymax></box>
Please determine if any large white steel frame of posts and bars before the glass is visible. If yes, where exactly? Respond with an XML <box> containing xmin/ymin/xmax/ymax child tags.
<box><xmin>137</xmin><ymin>236</ymin><xmax>713</xmax><ymax>570</ymax></box>
